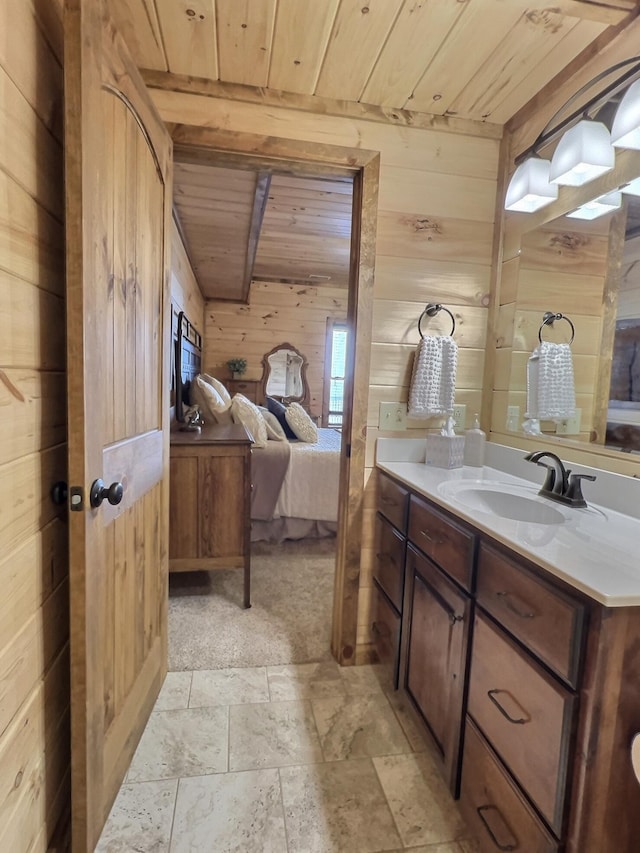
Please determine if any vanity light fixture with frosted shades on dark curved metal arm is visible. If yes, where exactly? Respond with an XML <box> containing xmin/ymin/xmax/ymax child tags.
<box><xmin>505</xmin><ymin>56</ymin><xmax>640</xmax><ymax>211</ymax></box>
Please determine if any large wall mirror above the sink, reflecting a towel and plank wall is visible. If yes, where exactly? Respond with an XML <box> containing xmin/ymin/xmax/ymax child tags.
<box><xmin>492</xmin><ymin>144</ymin><xmax>640</xmax><ymax>453</ymax></box>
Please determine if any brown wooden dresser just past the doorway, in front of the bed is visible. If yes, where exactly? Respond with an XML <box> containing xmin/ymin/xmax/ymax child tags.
<box><xmin>169</xmin><ymin>424</ymin><xmax>251</xmax><ymax>607</ymax></box>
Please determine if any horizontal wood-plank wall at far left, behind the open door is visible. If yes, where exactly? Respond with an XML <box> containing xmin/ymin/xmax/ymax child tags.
<box><xmin>0</xmin><ymin>0</ymin><xmax>70</xmax><ymax>853</ymax></box>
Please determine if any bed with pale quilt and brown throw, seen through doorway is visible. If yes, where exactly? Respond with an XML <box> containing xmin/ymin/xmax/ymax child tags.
<box><xmin>251</xmin><ymin>427</ymin><xmax>342</xmax><ymax>542</ymax></box>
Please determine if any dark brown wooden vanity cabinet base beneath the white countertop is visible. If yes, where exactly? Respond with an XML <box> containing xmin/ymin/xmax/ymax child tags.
<box><xmin>375</xmin><ymin>475</ymin><xmax>640</xmax><ymax>853</ymax></box>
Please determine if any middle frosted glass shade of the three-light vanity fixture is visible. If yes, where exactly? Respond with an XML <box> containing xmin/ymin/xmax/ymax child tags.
<box><xmin>549</xmin><ymin>119</ymin><xmax>616</xmax><ymax>187</ymax></box>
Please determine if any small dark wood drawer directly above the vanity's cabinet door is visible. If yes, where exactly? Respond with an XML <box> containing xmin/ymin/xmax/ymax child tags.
<box><xmin>409</xmin><ymin>495</ymin><xmax>475</xmax><ymax>590</ymax></box>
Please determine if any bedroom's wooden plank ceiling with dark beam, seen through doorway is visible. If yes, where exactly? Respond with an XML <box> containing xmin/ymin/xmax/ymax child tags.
<box><xmin>174</xmin><ymin>162</ymin><xmax>353</xmax><ymax>301</ymax></box>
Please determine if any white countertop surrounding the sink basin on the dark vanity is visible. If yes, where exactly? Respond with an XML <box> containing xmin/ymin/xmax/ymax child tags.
<box><xmin>376</xmin><ymin>440</ymin><xmax>640</xmax><ymax>607</ymax></box>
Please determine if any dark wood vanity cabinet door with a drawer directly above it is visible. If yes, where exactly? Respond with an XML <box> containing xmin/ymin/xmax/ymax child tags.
<box><xmin>406</xmin><ymin>547</ymin><xmax>471</xmax><ymax>795</ymax></box>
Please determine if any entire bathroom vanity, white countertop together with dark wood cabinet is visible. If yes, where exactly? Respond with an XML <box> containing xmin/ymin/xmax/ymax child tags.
<box><xmin>372</xmin><ymin>446</ymin><xmax>640</xmax><ymax>853</ymax></box>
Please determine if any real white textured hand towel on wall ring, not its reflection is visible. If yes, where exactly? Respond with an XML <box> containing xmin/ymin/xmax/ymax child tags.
<box><xmin>409</xmin><ymin>335</ymin><xmax>458</xmax><ymax>418</ymax></box>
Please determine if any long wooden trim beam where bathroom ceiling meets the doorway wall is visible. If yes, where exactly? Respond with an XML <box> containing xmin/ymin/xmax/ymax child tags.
<box><xmin>141</xmin><ymin>69</ymin><xmax>502</xmax><ymax>139</ymax></box>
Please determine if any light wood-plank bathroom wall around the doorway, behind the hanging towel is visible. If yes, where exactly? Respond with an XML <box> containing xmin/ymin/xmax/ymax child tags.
<box><xmin>151</xmin><ymin>89</ymin><xmax>499</xmax><ymax>660</ymax></box>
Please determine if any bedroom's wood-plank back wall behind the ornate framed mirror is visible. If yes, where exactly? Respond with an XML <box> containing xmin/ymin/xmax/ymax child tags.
<box><xmin>204</xmin><ymin>281</ymin><xmax>348</xmax><ymax>415</ymax></box>
